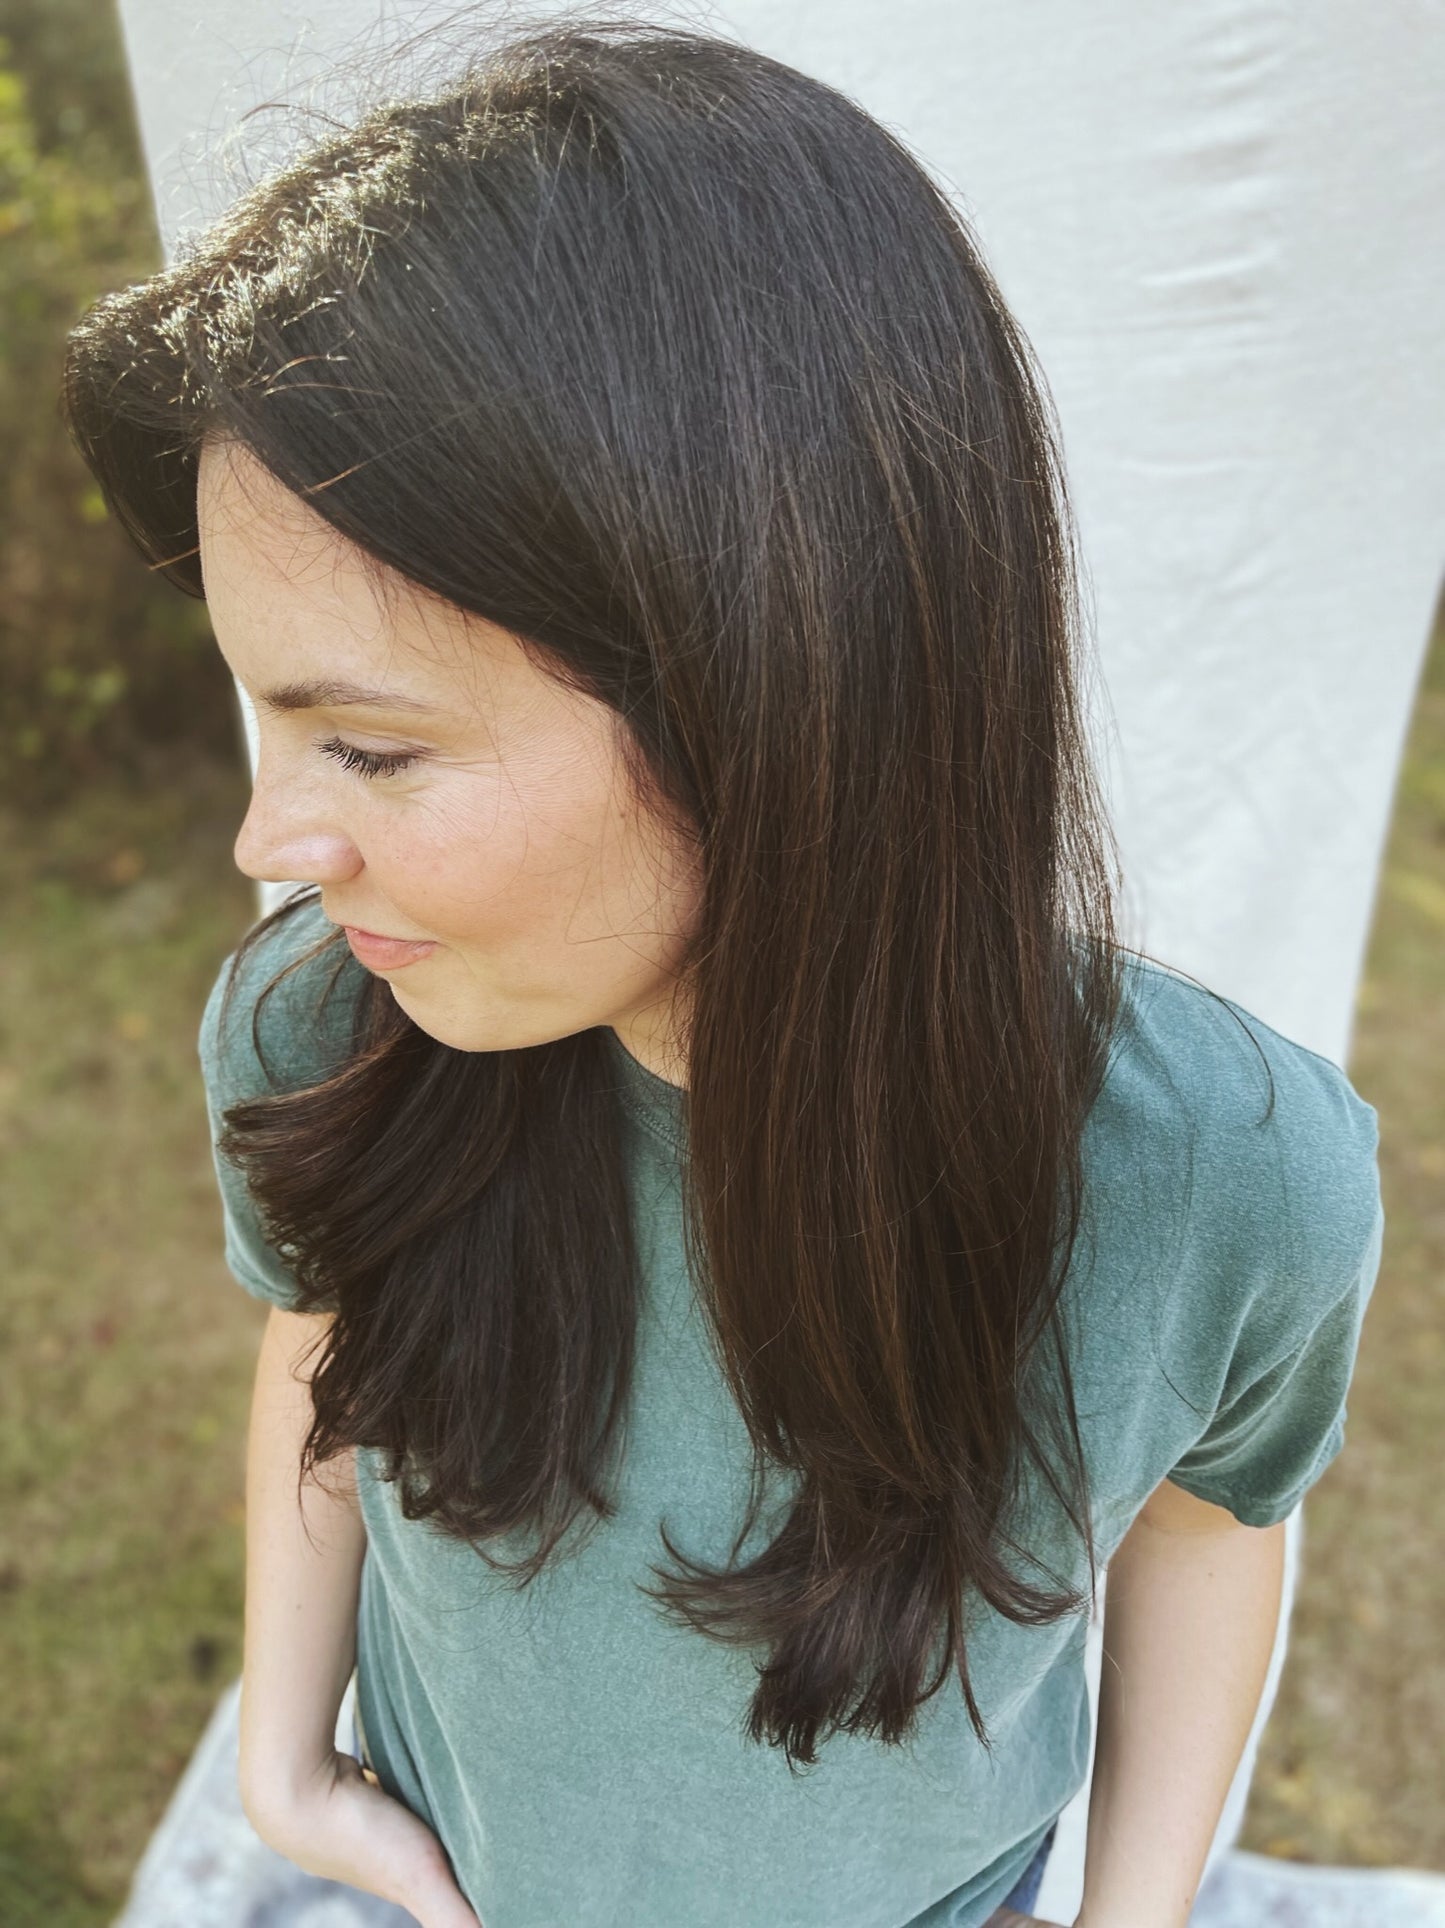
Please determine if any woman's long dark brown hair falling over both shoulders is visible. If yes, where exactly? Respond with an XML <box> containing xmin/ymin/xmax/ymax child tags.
<box><xmin>62</xmin><ymin>13</ymin><xmax>1123</xmax><ymax>1766</ymax></box>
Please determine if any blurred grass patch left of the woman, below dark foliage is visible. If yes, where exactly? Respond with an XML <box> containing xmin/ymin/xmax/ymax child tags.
<box><xmin>0</xmin><ymin>736</ymin><xmax>264</xmax><ymax>1928</ymax></box>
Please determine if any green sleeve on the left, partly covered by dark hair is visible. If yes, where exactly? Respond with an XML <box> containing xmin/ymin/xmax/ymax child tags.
<box><xmin>197</xmin><ymin>902</ymin><xmax>360</xmax><ymax>1311</ymax></box>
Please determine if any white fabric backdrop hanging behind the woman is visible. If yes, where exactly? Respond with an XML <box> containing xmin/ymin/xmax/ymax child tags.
<box><xmin>120</xmin><ymin>0</ymin><xmax>1445</xmax><ymax>1922</ymax></box>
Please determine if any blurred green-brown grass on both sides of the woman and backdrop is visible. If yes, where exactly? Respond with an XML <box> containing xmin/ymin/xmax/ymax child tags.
<box><xmin>0</xmin><ymin>630</ymin><xmax>1445</xmax><ymax>1928</ymax></box>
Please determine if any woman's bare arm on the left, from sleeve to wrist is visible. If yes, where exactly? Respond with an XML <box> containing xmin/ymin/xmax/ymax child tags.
<box><xmin>239</xmin><ymin>1307</ymin><xmax>367</xmax><ymax>1832</ymax></box>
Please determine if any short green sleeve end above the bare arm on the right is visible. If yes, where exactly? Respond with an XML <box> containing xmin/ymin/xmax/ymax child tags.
<box><xmin>1169</xmin><ymin>1188</ymin><xmax>1385</xmax><ymax>1527</ymax></box>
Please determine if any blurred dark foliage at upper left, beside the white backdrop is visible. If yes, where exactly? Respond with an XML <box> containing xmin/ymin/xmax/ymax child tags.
<box><xmin>0</xmin><ymin>0</ymin><xmax>239</xmax><ymax>808</ymax></box>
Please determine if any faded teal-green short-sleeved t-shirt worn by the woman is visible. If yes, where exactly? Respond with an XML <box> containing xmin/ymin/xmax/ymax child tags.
<box><xmin>201</xmin><ymin>900</ymin><xmax>1383</xmax><ymax>1928</ymax></box>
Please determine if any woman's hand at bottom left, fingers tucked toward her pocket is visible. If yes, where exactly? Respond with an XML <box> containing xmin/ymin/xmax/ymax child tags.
<box><xmin>245</xmin><ymin>1749</ymin><xmax>482</xmax><ymax>1928</ymax></box>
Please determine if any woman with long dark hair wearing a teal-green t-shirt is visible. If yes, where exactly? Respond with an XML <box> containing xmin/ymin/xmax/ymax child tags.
<box><xmin>64</xmin><ymin>15</ymin><xmax>1383</xmax><ymax>1928</ymax></box>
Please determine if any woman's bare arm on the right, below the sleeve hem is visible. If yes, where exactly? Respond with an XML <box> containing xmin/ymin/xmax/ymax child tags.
<box><xmin>1077</xmin><ymin>1479</ymin><xmax>1285</xmax><ymax>1928</ymax></box>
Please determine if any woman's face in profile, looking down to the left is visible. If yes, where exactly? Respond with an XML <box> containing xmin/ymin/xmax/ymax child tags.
<box><xmin>197</xmin><ymin>442</ymin><xmax>696</xmax><ymax>1084</ymax></box>
